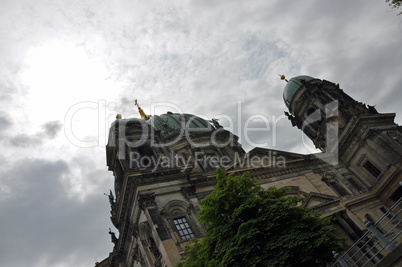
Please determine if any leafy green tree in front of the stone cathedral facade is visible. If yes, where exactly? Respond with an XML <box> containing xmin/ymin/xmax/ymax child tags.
<box><xmin>177</xmin><ymin>169</ymin><xmax>343</xmax><ymax>267</ymax></box>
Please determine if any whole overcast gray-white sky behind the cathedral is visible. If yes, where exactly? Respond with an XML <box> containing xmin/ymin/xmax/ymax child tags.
<box><xmin>0</xmin><ymin>0</ymin><xmax>402</xmax><ymax>267</ymax></box>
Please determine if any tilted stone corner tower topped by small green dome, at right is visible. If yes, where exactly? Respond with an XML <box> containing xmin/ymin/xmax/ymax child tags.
<box><xmin>283</xmin><ymin>76</ymin><xmax>402</xmax><ymax>202</ymax></box>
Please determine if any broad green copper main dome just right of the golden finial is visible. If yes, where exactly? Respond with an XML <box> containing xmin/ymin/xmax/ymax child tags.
<box><xmin>146</xmin><ymin>112</ymin><xmax>214</xmax><ymax>132</ymax></box>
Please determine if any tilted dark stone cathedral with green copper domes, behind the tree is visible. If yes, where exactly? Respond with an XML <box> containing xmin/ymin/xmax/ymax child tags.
<box><xmin>96</xmin><ymin>76</ymin><xmax>402</xmax><ymax>267</ymax></box>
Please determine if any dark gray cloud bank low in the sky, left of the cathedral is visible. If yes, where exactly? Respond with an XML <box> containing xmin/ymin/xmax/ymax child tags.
<box><xmin>0</xmin><ymin>159</ymin><xmax>110</xmax><ymax>266</ymax></box>
